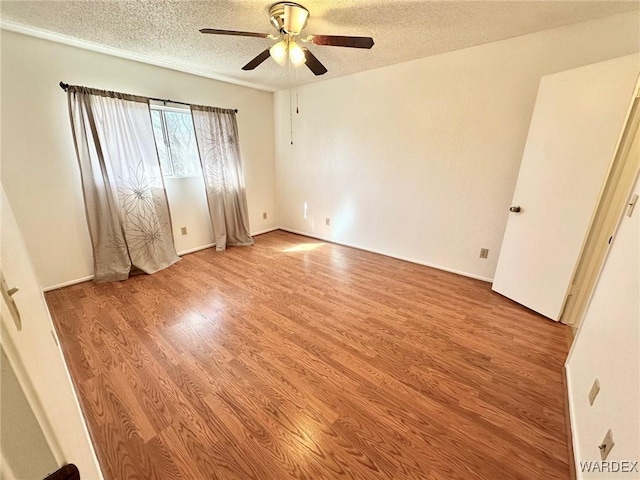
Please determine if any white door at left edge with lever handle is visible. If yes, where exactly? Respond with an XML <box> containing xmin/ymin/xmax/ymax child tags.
<box><xmin>0</xmin><ymin>189</ymin><xmax>102</xmax><ymax>480</ymax></box>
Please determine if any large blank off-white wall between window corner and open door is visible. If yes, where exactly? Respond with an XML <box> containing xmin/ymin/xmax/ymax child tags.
<box><xmin>275</xmin><ymin>12</ymin><xmax>640</xmax><ymax>279</ymax></box>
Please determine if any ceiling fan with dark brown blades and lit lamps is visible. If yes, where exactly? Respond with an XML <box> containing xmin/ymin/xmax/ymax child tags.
<box><xmin>200</xmin><ymin>2</ymin><xmax>373</xmax><ymax>75</ymax></box>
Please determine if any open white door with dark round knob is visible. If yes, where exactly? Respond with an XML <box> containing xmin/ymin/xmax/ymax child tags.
<box><xmin>493</xmin><ymin>55</ymin><xmax>639</xmax><ymax>320</ymax></box>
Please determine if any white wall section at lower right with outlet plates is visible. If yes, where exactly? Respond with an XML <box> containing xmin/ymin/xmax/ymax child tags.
<box><xmin>566</xmin><ymin>174</ymin><xmax>640</xmax><ymax>480</ymax></box>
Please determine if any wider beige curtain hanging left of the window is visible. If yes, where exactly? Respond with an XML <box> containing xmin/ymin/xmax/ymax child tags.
<box><xmin>67</xmin><ymin>86</ymin><xmax>180</xmax><ymax>281</ymax></box>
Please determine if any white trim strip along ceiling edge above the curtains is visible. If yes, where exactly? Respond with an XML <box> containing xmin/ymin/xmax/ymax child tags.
<box><xmin>0</xmin><ymin>20</ymin><xmax>277</xmax><ymax>92</ymax></box>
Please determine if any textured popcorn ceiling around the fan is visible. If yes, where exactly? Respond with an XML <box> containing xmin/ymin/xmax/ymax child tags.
<box><xmin>0</xmin><ymin>0</ymin><xmax>640</xmax><ymax>90</ymax></box>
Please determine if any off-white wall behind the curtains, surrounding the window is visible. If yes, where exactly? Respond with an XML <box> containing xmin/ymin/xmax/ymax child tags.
<box><xmin>1</xmin><ymin>30</ymin><xmax>278</xmax><ymax>287</ymax></box>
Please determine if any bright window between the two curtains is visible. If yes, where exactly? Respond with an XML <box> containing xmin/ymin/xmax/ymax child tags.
<box><xmin>151</xmin><ymin>105</ymin><xmax>200</xmax><ymax>177</ymax></box>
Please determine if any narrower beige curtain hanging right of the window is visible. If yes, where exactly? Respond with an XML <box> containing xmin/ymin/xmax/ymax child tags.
<box><xmin>191</xmin><ymin>105</ymin><xmax>253</xmax><ymax>250</ymax></box>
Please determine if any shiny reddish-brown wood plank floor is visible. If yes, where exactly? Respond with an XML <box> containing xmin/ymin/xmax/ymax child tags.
<box><xmin>46</xmin><ymin>231</ymin><xmax>569</xmax><ymax>480</ymax></box>
